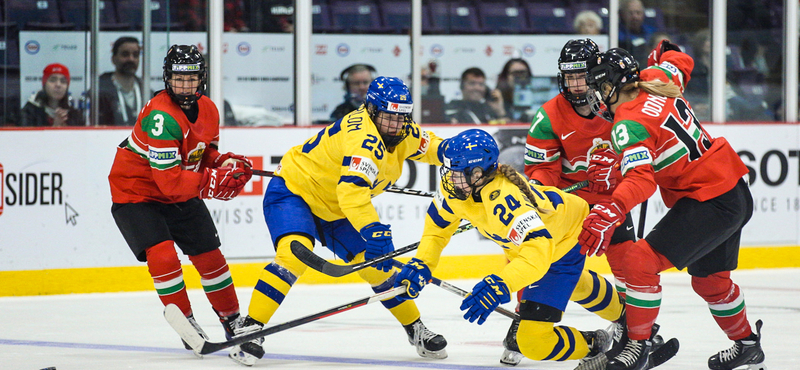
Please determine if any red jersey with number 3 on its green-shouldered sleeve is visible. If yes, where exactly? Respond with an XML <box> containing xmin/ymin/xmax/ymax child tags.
<box><xmin>108</xmin><ymin>91</ymin><xmax>219</xmax><ymax>203</ymax></box>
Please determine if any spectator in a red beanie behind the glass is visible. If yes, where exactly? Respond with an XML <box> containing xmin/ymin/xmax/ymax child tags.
<box><xmin>20</xmin><ymin>63</ymin><xmax>84</xmax><ymax>127</ymax></box>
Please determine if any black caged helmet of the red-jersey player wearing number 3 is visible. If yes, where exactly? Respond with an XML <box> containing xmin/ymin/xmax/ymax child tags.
<box><xmin>163</xmin><ymin>45</ymin><xmax>207</xmax><ymax>105</ymax></box>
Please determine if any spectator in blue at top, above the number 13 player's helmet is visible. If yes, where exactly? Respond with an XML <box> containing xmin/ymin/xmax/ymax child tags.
<box><xmin>619</xmin><ymin>0</ymin><xmax>656</xmax><ymax>61</ymax></box>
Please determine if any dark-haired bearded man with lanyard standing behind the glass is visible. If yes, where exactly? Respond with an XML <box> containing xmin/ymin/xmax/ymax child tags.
<box><xmin>97</xmin><ymin>36</ymin><xmax>144</xmax><ymax>126</ymax></box>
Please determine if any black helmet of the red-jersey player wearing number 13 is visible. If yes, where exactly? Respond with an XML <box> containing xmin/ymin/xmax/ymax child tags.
<box><xmin>586</xmin><ymin>48</ymin><xmax>639</xmax><ymax>122</ymax></box>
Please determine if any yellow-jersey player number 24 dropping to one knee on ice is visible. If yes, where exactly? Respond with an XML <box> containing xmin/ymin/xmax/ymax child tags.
<box><xmin>395</xmin><ymin>129</ymin><xmax>623</xmax><ymax>368</ymax></box>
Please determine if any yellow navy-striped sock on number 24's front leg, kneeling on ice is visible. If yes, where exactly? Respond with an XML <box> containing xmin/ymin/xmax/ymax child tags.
<box><xmin>517</xmin><ymin>319</ymin><xmax>588</xmax><ymax>361</ymax></box>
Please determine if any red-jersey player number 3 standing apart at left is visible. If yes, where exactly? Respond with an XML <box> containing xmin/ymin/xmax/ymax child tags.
<box><xmin>108</xmin><ymin>45</ymin><xmax>252</xmax><ymax>349</ymax></box>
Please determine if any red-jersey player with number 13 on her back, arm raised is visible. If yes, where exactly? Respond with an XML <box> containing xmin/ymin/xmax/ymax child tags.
<box><xmin>579</xmin><ymin>41</ymin><xmax>765</xmax><ymax>370</ymax></box>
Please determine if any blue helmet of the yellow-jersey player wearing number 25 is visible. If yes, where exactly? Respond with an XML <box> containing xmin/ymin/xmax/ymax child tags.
<box><xmin>366</xmin><ymin>76</ymin><xmax>414</xmax><ymax>148</ymax></box>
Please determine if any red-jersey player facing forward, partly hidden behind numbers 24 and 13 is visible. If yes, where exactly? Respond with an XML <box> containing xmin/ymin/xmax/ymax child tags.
<box><xmin>520</xmin><ymin>39</ymin><xmax>636</xmax><ymax>366</ymax></box>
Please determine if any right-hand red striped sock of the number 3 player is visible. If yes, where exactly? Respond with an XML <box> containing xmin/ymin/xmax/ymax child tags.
<box><xmin>189</xmin><ymin>248</ymin><xmax>239</xmax><ymax>317</ymax></box>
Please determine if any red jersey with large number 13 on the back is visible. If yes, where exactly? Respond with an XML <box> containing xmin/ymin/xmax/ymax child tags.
<box><xmin>611</xmin><ymin>52</ymin><xmax>748</xmax><ymax>214</ymax></box>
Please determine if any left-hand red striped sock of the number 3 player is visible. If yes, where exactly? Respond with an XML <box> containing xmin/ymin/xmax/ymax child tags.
<box><xmin>146</xmin><ymin>240</ymin><xmax>192</xmax><ymax>316</ymax></box>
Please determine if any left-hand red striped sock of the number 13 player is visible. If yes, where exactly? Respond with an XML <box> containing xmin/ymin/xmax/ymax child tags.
<box><xmin>623</xmin><ymin>239</ymin><xmax>672</xmax><ymax>340</ymax></box>
